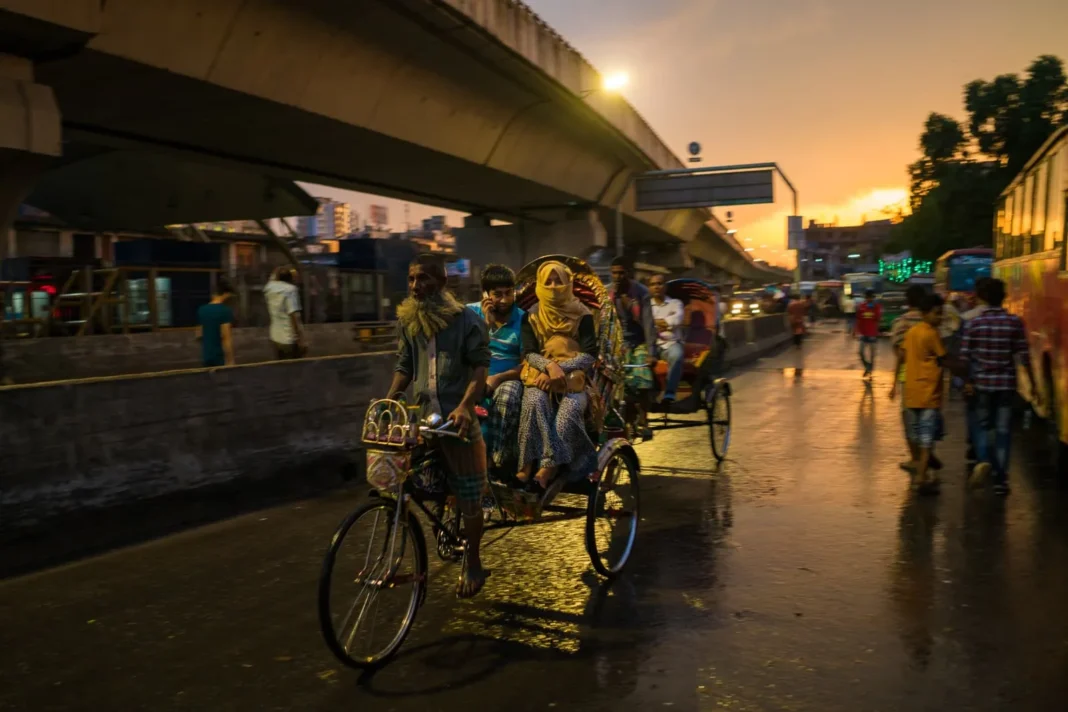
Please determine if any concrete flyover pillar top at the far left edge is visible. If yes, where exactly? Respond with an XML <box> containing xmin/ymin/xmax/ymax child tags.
<box><xmin>0</xmin><ymin>53</ymin><xmax>62</xmax><ymax>258</ymax></box>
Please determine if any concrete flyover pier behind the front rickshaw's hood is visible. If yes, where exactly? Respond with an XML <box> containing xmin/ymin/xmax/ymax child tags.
<box><xmin>454</xmin><ymin>210</ymin><xmax>608</xmax><ymax>270</ymax></box>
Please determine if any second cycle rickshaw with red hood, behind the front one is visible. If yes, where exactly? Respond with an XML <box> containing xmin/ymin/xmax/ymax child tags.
<box><xmin>627</xmin><ymin>279</ymin><xmax>731</xmax><ymax>462</ymax></box>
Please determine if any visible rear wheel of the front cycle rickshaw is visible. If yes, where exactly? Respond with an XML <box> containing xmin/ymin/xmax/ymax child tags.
<box><xmin>586</xmin><ymin>448</ymin><xmax>640</xmax><ymax>579</ymax></box>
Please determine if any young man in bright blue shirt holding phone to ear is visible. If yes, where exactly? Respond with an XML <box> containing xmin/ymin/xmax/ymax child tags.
<box><xmin>468</xmin><ymin>265</ymin><xmax>523</xmax><ymax>468</ymax></box>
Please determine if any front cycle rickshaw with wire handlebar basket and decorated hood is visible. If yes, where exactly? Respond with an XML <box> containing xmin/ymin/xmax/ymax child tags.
<box><xmin>318</xmin><ymin>255</ymin><xmax>639</xmax><ymax>668</ymax></box>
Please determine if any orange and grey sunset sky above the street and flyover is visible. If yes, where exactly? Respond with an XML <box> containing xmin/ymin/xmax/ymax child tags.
<box><xmin>313</xmin><ymin>0</ymin><xmax>1068</xmax><ymax>265</ymax></box>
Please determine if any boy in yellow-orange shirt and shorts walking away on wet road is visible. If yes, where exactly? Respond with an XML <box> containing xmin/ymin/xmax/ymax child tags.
<box><xmin>890</xmin><ymin>295</ymin><xmax>946</xmax><ymax>494</ymax></box>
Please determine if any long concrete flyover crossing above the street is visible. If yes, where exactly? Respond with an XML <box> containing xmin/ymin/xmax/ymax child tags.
<box><xmin>0</xmin><ymin>0</ymin><xmax>783</xmax><ymax>280</ymax></box>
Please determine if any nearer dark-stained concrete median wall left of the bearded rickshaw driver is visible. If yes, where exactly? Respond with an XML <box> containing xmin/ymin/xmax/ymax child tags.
<box><xmin>0</xmin><ymin>354</ymin><xmax>394</xmax><ymax>575</ymax></box>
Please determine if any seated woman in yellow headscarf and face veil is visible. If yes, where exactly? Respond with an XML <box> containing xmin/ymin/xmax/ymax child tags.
<box><xmin>517</xmin><ymin>262</ymin><xmax>597</xmax><ymax>489</ymax></box>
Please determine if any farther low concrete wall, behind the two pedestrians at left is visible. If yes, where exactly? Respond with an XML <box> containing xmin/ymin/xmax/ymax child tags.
<box><xmin>2</xmin><ymin>322</ymin><xmax>393</xmax><ymax>383</ymax></box>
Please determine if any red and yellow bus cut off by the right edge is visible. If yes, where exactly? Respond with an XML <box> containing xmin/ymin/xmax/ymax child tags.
<box><xmin>994</xmin><ymin>127</ymin><xmax>1068</xmax><ymax>459</ymax></box>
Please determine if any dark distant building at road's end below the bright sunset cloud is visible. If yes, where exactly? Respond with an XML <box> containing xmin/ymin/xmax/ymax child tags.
<box><xmin>798</xmin><ymin>220</ymin><xmax>893</xmax><ymax>280</ymax></box>
